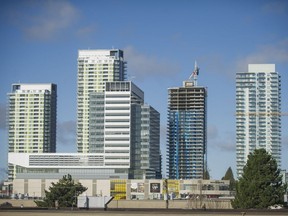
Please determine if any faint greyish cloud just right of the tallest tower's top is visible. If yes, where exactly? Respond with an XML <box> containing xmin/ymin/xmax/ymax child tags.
<box><xmin>124</xmin><ymin>46</ymin><xmax>180</xmax><ymax>80</ymax></box>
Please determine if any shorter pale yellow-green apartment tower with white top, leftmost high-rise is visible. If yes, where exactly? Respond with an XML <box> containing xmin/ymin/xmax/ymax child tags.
<box><xmin>7</xmin><ymin>84</ymin><xmax>57</xmax><ymax>180</ymax></box>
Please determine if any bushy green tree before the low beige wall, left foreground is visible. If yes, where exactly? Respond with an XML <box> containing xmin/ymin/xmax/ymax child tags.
<box><xmin>35</xmin><ymin>174</ymin><xmax>87</xmax><ymax>207</ymax></box>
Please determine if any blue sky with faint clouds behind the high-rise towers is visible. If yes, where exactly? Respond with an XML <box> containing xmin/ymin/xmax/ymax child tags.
<box><xmin>0</xmin><ymin>0</ymin><xmax>288</xmax><ymax>179</ymax></box>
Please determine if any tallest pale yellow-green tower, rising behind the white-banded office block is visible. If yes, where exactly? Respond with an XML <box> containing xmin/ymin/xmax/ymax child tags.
<box><xmin>77</xmin><ymin>49</ymin><xmax>126</xmax><ymax>153</ymax></box>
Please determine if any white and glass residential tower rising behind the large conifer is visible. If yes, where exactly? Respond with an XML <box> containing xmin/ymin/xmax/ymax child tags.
<box><xmin>236</xmin><ymin>64</ymin><xmax>281</xmax><ymax>177</ymax></box>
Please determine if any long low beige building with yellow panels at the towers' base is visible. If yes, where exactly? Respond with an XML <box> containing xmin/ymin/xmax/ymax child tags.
<box><xmin>13</xmin><ymin>179</ymin><xmax>230</xmax><ymax>201</ymax></box>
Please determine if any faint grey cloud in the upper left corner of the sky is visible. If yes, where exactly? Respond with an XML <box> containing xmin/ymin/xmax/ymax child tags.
<box><xmin>10</xmin><ymin>0</ymin><xmax>79</xmax><ymax>40</ymax></box>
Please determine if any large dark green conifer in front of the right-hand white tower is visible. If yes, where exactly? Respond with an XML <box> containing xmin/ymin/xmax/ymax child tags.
<box><xmin>232</xmin><ymin>149</ymin><xmax>287</xmax><ymax>209</ymax></box>
